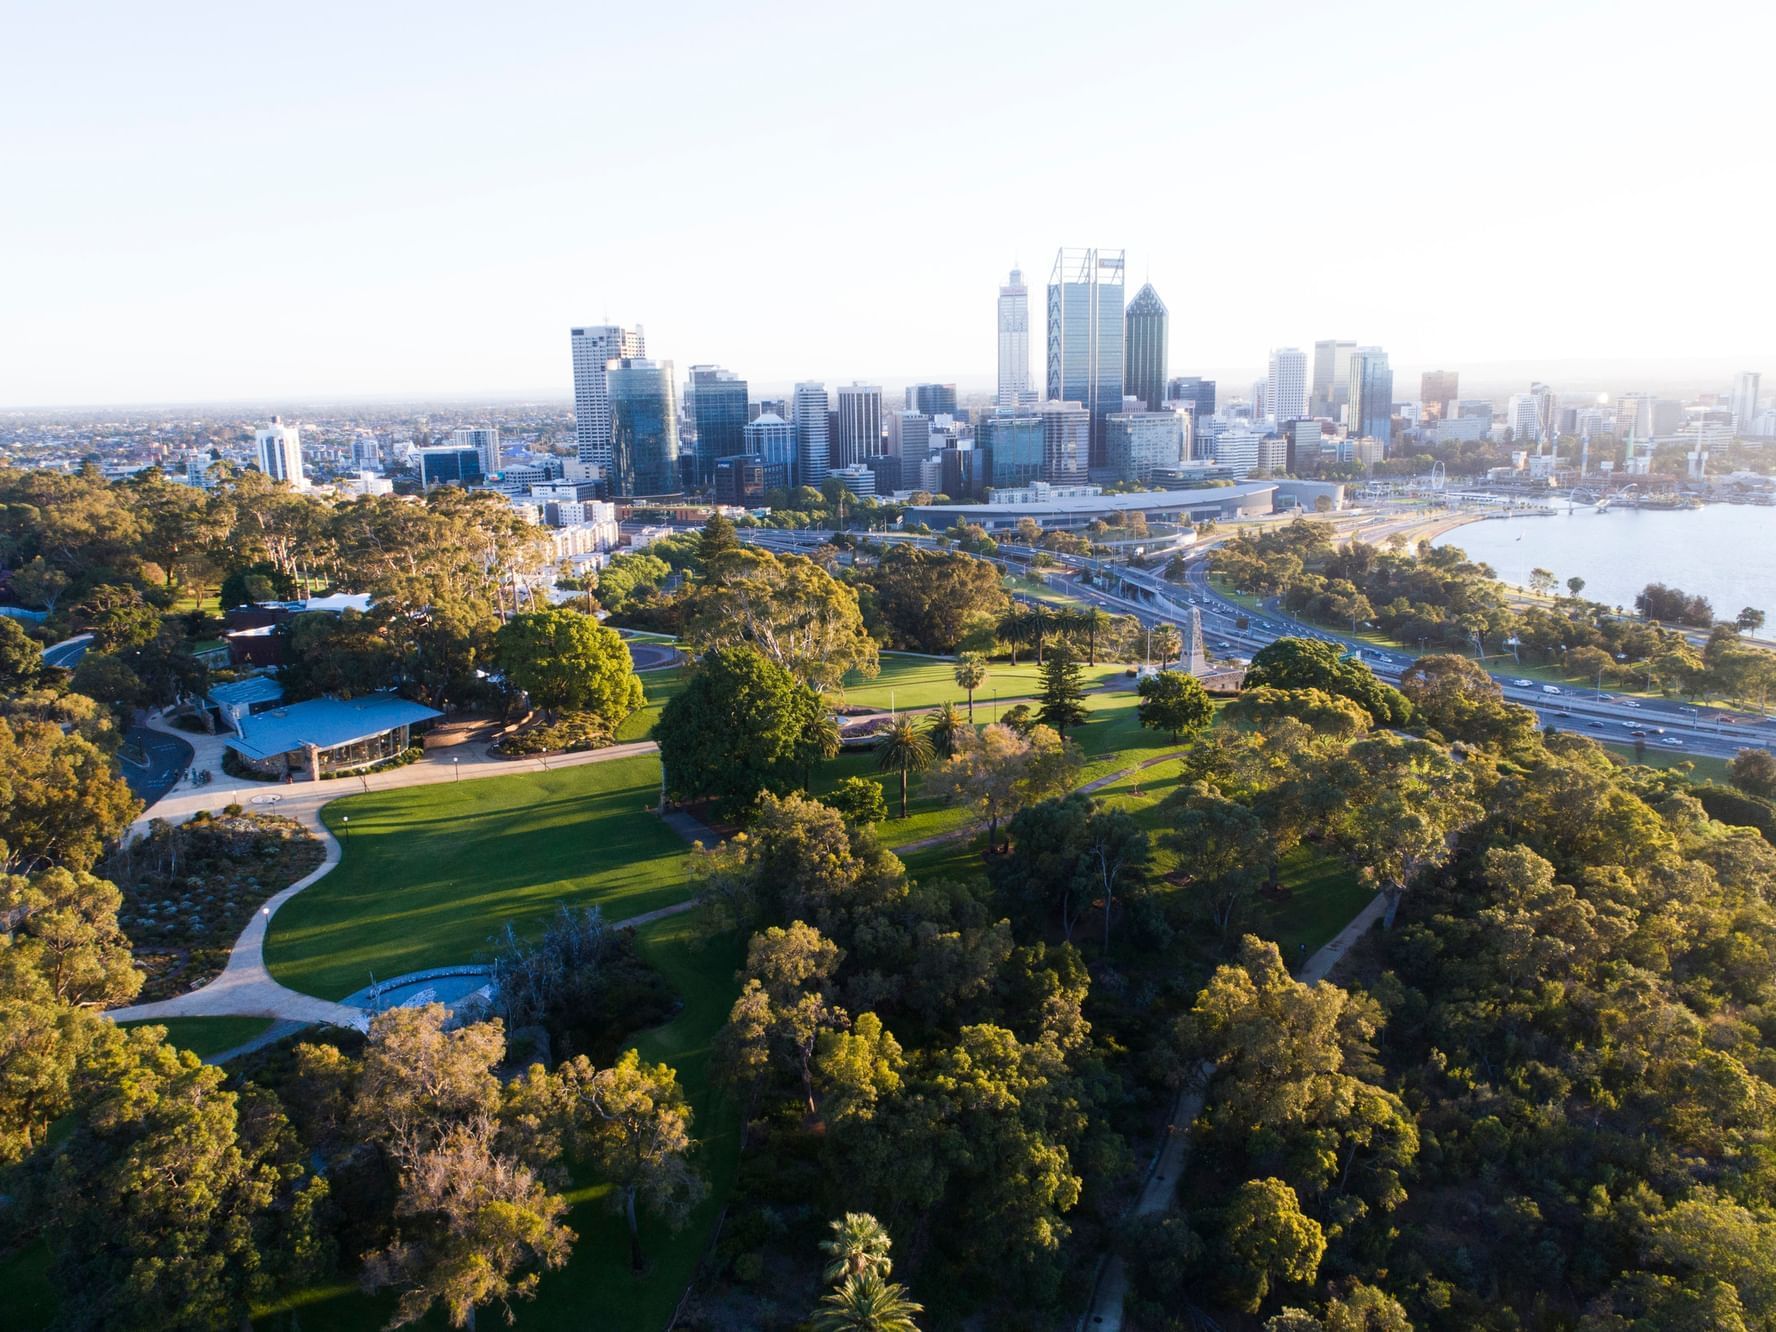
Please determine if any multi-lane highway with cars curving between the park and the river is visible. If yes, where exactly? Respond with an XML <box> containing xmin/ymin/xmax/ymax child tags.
<box><xmin>748</xmin><ymin>529</ymin><xmax>1776</xmax><ymax>758</ymax></box>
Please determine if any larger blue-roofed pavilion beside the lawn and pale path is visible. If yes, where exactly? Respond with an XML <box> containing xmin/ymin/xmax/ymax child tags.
<box><xmin>227</xmin><ymin>693</ymin><xmax>444</xmax><ymax>781</ymax></box>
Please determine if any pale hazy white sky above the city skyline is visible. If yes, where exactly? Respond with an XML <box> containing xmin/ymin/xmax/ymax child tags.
<box><xmin>0</xmin><ymin>0</ymin><xmax>1776</xmax><ymax>405</ymax></box>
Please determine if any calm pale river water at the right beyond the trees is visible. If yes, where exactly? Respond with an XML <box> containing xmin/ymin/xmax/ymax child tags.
<box><xmin>1437</xmin><ymin>504</ymin><xmax>1776</xmax><ymax>632</ymax></box>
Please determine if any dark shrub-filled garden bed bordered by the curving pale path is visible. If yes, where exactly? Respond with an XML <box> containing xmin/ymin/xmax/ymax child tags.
<box><xmin>103</xmin><ymin>813</ymin><xmax>325</xmax><ymax>1000</ymax></box>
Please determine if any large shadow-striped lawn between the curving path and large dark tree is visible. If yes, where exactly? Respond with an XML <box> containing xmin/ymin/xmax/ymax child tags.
<box><xmin>265</xmin><ymin>755</ymin><xmax>687</xmax><ymax>998</ymax></box>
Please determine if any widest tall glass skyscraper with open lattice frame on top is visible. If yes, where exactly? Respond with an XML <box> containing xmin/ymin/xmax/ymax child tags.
<box><xmin>1048</xmin><ymin>249</ymin><xmax>1122</xmax><ymax>464</ymax></box>
